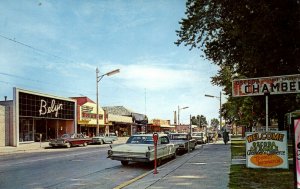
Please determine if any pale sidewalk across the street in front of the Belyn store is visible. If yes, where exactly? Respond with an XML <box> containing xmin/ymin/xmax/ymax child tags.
<box><xmin>0</xmin><ymin>137</ymin><xmax>128</xmax><ymax>156</ymax></box>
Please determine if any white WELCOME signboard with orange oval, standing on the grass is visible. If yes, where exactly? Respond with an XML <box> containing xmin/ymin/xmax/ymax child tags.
<box><xmin>246</xmin><ymin>131</ymin><xmax>289</xmax><ymax>169</ymax></box>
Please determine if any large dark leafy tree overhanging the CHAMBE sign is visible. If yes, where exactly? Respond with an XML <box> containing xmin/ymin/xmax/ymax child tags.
<box><xmin>175</xmin><ymin>0</ymin><xmax>300</xmax><ymax>128</ymax></box>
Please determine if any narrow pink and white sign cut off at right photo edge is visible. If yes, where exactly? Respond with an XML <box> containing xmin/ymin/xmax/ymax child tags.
<box><xmin>294</xmin><ymin>119</ymin><xmax>300</xmax><ymax>188</ymax></box>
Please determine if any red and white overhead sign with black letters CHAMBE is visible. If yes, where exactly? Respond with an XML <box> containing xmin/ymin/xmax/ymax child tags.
<box><xmin>232</xmin><ymin>74</ymin><xmax>300</xmax><ymax>97</ymax></box>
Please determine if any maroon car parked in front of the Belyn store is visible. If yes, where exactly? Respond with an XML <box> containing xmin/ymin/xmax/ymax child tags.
<box><xmin>49</xmin><ymin>133</ymin><xmax>92</xmax><ymax>148</ymax></box>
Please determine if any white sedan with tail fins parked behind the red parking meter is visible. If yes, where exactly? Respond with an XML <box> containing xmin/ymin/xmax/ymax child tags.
<box><xmin>108</xmin><ymin>134</ymin><xmax>177</xmax><ymax>165</ymax></box>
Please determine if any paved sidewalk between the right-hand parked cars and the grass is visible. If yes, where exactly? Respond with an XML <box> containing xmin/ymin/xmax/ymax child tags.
<box><xmin>115</xmin><ymin>140</ymin><xmax>231</xmax><ymax>189</ymax></box>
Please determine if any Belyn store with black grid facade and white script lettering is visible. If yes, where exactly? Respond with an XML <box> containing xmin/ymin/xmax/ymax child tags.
<box><xmin>0</xmin><ymin>88</ymin><xmax>76</xmax><ymax>146</ymax></box>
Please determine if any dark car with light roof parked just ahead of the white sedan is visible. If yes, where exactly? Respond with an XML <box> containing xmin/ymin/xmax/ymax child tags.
<box><xmin>169</xmin><ymin>133</ymin><xmax>196</xmax><ymax>153</ymax></box>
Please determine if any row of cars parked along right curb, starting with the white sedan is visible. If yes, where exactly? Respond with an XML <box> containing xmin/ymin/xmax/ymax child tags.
<box><xmin>108</xmin><ymin>133</ymin><xmax>206</xmax><ymax>165</ymax></box>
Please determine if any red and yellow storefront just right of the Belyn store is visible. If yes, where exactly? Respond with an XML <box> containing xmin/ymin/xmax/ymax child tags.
<box><xmin>71</xmin><ymin>97</ymin><xmax>109</xmax><ymax>137</ymax></box>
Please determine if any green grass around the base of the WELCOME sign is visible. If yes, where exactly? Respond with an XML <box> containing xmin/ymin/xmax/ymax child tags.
<box><xmin>229</xmin><ymin>138</ymin><xmax>295</xmax><ymax>189</ymax></box>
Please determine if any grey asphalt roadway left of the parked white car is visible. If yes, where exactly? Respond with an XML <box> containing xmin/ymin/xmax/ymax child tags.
<box><xmin>0</xmin><ymin>145</ymin><xmax>151</xmax><ymax>188</ymax></box>
